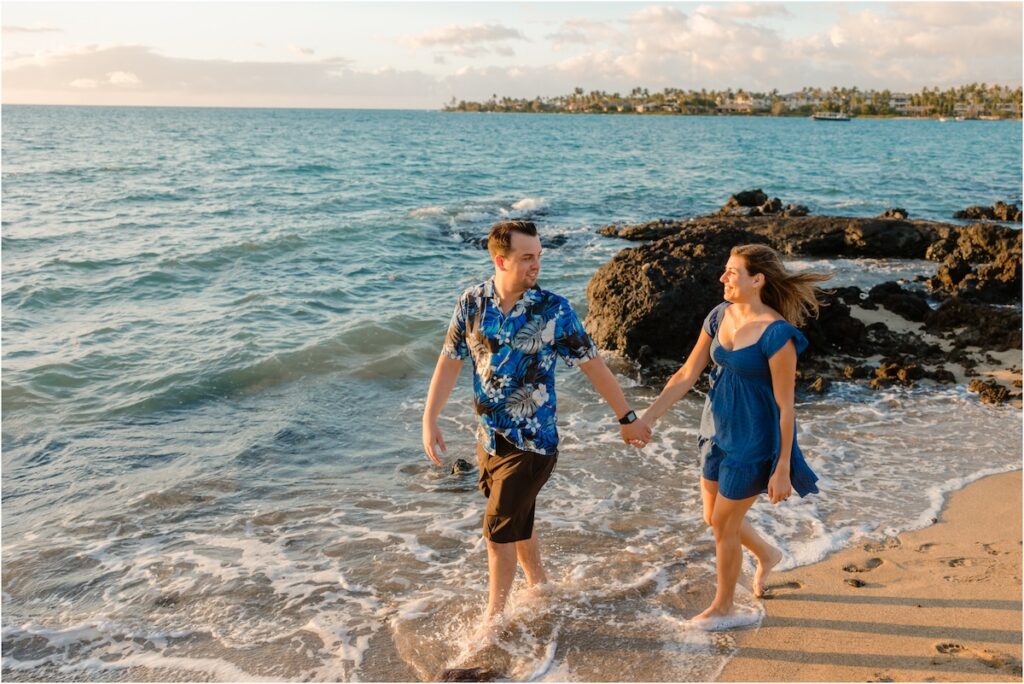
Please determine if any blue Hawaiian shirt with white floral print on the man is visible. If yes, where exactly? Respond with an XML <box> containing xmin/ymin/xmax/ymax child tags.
<box><xmin>441</xmin><ymin>277</ymin><xmax>598</xmax><ymax>456</ymax></box>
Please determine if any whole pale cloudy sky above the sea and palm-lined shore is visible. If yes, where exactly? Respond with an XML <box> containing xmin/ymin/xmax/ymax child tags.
<box><xmin>6</xmin><ymin>0</ymin><xmax>1024</xmax><ymax>110</ymax></box>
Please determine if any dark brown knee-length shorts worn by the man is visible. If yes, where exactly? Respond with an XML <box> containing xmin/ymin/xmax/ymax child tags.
<box><xmin>476</xmin><ymin>434</ymin><xmax>558</xmax><ymax>544</ymax></box>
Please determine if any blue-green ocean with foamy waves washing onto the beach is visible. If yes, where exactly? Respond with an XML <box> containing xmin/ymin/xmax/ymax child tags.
<box><xmin>2</xmin><ymin>106</ymin><xmax>1022</xmax><ymax>681</ymax></box>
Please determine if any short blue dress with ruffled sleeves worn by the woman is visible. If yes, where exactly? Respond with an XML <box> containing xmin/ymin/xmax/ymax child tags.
<box><xmin>697</xmin><ymin>302</ymin><xmax>818</xmax><ymax>500</ymax></box>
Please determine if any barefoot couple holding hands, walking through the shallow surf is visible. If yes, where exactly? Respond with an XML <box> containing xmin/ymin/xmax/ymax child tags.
<box><xmin>423</xmin><ymin>221</ymin><xmax>828</xmax><ymax>631</ymax></box>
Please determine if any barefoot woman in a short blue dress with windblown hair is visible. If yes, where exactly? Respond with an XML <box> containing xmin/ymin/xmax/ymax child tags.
<box><xmin>643</xmin><ymin>245</ymin><xmax>830</xmax><ymax>630</ymax></box>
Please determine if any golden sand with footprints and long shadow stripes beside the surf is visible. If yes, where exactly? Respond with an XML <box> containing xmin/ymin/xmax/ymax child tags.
<box><xmin>718</xmin><ymin>471</ymin><xmax>1022</xmax><ymax>682</ymax></box>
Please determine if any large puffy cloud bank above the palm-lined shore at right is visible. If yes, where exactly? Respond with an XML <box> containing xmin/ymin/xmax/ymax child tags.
<box><xmin>532</xmin><ymin>3</ymin><xmax>1022</xmax><ymax>92</ymax></box>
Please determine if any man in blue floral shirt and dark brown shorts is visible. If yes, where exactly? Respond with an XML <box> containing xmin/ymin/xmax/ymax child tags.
<box><xmin>423</xmin><ymin>221</ymin><xmax>651</xmax><ymax>628</ymax></box>
